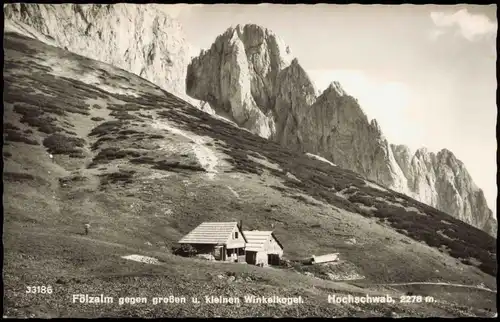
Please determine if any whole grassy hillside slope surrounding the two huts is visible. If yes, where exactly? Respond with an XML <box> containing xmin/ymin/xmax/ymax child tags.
<box><xmin>3</xmin><ymin>33</ymin><xmax>496</xmax><ymax>317</ymax></box>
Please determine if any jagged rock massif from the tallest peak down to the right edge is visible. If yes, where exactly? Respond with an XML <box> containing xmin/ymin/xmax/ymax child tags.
<box><xmin>186</xmin><ymin>25</ymin><xmax>496</xmax><ymax>235</ymax></box>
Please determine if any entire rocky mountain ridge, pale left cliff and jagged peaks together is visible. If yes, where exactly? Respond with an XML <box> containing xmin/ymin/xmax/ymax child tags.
<box><xmin>4</xmin><ymin>4</ymin><xmax>497</xmax><ymax>235</ymax></box>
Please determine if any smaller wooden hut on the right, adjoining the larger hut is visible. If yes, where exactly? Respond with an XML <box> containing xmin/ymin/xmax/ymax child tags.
<box><xmin>243</xmin><ymin>230</ymin><xmax>283</xmax><ymax>266</ymax></box>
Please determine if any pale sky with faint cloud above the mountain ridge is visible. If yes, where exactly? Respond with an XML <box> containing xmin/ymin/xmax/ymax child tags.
<box><xmin>159</xmin><ymin>4</ymin><xmax>498</xmax><ymax>214</ymax></box>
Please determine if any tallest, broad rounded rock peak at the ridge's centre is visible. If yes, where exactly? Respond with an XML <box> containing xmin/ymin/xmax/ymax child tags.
<box><xmin>186</xmin><ymin>24</ymin><xmax>304</xmax><ymax>138</ymax></box>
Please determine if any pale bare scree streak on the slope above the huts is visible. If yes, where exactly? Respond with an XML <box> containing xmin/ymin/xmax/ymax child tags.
<box><xmin>152</xmin><ymin>120</ymin><xmax>219</xmax><ymax>180</ymax></box>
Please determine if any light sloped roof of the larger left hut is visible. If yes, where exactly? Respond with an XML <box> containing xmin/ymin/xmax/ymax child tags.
<box><xmin>179</xmin><ymin>221</ymin><xmax>238</xmax><ymax>244</ymax></box>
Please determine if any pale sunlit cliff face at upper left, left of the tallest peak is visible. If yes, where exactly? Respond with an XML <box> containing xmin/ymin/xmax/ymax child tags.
<box><xmin>4</xmin><ymin>3</ymin><xmax>209</xmax><ymax>111</ymax></box>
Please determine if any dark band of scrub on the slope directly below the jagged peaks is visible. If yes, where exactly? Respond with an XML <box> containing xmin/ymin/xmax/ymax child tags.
<box><xmin>158</xmin><ymin>98</ymin><xmax>497</xmax><ymax>276</ymax></box>
